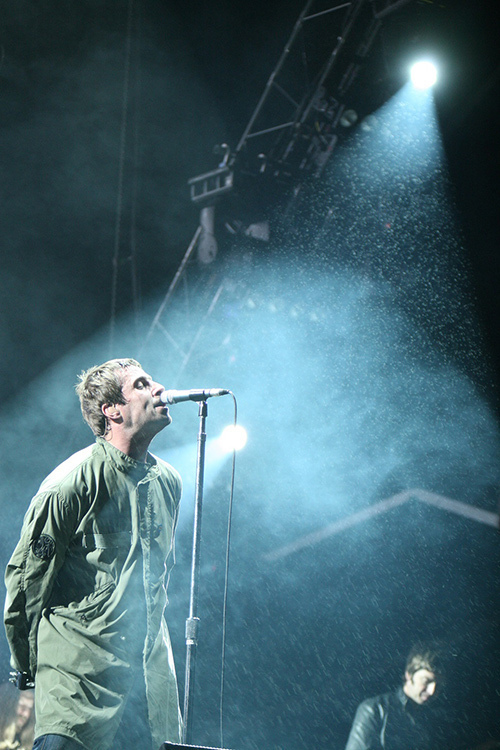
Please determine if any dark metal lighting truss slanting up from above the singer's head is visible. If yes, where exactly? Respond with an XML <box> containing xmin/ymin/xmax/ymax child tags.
<box><xmin>139</xmin><ymin>0</ymin><xmax>416</xmax><ymax>376</ymax></box>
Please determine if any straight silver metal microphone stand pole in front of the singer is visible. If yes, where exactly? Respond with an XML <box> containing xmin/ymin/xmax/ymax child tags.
<box><xmin>182</xmin><ymin>401</ymin><xmax>208</xmax><ymax>745</ymax></box>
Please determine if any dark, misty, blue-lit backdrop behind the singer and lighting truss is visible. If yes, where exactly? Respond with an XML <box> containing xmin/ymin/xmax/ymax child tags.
<box><xmin>0</xmin><ymin>0</ymin><xmax>500</xmax><ymax>750</ymax></box>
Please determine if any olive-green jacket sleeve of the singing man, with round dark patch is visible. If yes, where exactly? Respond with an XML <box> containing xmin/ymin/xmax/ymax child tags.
<box><xmin>4</xmin><ymin>492</ymin><xmax>77</xmax><ymax>678</ymax></box>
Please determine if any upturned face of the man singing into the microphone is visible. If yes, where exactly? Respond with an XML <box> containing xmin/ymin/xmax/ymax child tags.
<box><xmin>112</xmin><ymin>367</ymin><xmax>172</xmax><ymax>440</ymax></box>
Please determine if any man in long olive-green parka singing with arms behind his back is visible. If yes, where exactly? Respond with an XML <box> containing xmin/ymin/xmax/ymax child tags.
<box><xmin>5</xmin><ymin>359</ymin><xmax>181</xmax><ymax>750</ymax></box>
